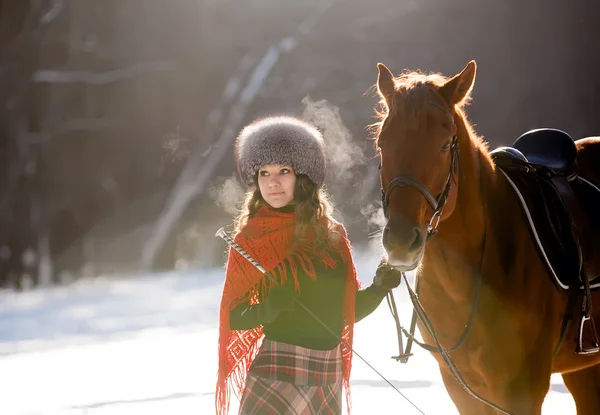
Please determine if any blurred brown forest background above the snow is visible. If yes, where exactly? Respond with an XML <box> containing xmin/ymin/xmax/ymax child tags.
<box><xmin>0</xmin><ymin>0</ymin><xmax>600</xmax><ymax>288</ymax></box>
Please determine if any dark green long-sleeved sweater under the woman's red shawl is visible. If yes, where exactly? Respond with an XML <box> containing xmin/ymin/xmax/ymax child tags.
<box><xmin>229</xmin><ymin>250</ymin><xmax>387</xmax><ymax>350</ymax></box>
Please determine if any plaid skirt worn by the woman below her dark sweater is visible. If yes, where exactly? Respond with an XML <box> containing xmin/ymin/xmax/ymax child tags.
<box><xmin>239</xmin><ymin>339</ymin><xmax>343</xmax><ymax>415</ymax></box>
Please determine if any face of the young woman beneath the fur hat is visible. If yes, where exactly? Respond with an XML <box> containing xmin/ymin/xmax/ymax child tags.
<box><xmin>258</xmin><ymin>164</ymin><xmax>296</xmax><ymax>209</ymax></box>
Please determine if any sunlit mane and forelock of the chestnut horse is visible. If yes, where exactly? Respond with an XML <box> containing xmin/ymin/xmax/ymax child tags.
<box><xmin>367</xmin><ymin>71</ymin><xmax>488</xmax><ymax>158</ymax></box>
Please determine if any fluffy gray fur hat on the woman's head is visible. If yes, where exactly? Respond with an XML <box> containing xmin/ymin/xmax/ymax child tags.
<box><xmin>235</xmin><ymin>116</ymin><xmax>327</xmax><ymax>187</ymax></box>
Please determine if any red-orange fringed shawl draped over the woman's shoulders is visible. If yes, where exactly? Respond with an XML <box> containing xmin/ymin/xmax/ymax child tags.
<box><xmin>215</xmin><ymin>207</ymin><xmax>360</xmax><ymax>415</ymax></box>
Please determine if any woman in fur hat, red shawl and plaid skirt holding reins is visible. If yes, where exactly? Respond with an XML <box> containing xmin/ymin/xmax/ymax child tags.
<box><xmin>216</xmin><ymin>116</ymin><xmax>400</xmax><ymax>415</ymax></box>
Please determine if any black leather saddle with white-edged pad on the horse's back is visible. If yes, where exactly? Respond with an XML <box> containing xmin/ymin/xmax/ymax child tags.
<box><xmin>491</xmin><ymin>128</ymin><xmax>600</xmax><ymax>290</ymax></box>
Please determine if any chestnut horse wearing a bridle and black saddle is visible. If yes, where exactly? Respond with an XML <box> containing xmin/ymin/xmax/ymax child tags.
<box><xmin>370</xmin><ymin>61</ymin><xmax>600</xmax><ymax>415</ymax></box>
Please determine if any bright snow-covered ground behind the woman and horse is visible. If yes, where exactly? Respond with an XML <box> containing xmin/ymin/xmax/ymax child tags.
<box><xmin>0</xmin><ymin>249</ymin><xmax>575</xmax><ymax>415</ymax></box>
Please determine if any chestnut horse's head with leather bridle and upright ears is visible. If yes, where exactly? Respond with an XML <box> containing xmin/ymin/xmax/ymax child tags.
<box><xmin>376</xmin><ymin>61</ymin><xmax>476</xmax><ymax>270</ymax></box>
